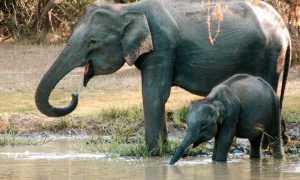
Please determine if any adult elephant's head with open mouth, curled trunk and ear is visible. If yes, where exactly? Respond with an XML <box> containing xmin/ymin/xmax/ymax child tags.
<box><xmin>35</xmin><ymin>5</ymin><xmax>153</xmax><ymax>117</ymax></box>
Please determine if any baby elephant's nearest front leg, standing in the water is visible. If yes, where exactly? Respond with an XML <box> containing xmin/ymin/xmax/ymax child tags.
<box><xmin>212</xmin><ymin>126</ymin><xmax>235</xmax><ymax>161</ymax></box>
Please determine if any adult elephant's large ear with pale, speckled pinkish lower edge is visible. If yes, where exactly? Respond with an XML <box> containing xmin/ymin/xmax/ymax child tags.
<box><xmin>121</xmin><ymin>12</ymin><xmax>153</xmax><ymax>65</ymax></box>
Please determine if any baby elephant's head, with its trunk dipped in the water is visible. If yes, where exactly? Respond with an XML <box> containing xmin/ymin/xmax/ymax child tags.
<box><xmin>169</xmin><ymin>100</ymin><xmax>225</xmax><ymax>165</ymax></box>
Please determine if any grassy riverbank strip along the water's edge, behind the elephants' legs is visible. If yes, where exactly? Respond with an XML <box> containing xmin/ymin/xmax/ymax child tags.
<box><xmin>0</xmin><ymin>106</ymin><xmax>300</xmax><ymax>160</ymax></box>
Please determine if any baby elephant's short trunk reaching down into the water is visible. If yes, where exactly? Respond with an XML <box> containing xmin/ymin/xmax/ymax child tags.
<box><xmin>169</xmin><ymin>133</ymin><xmax>195</xmax><ymax>165</ymax></box>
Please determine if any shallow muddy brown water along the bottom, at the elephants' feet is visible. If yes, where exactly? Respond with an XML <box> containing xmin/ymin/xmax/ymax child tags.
<box><xmin>0</xmin><ymin>137</ymin><xmax>300</xmax><ymax>180</ymax></box>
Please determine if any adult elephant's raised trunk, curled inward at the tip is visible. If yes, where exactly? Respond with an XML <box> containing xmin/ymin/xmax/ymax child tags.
<box><xmin>35</xmin><ymin>47</ymin><xmax>81</xmax><ymax>117</ymax></box>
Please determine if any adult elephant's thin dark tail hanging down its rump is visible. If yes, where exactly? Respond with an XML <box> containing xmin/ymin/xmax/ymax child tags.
<box><xmin>279</xmin><ymin>43</ymin><xmax>292</xmax><ymax>110</ymax></box>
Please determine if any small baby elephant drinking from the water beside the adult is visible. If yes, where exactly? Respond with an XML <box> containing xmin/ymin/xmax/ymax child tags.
<box><xmin>169</xmin><ymin>74</ymin><xmax>283</xmax><ymax>165</ymax></box>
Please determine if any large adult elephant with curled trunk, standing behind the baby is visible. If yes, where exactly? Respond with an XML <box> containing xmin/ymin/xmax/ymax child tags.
<box><xmin>35</xmin><ymin>0</ymin><xmax>291</xmax><ymax>150</ymax></box>
